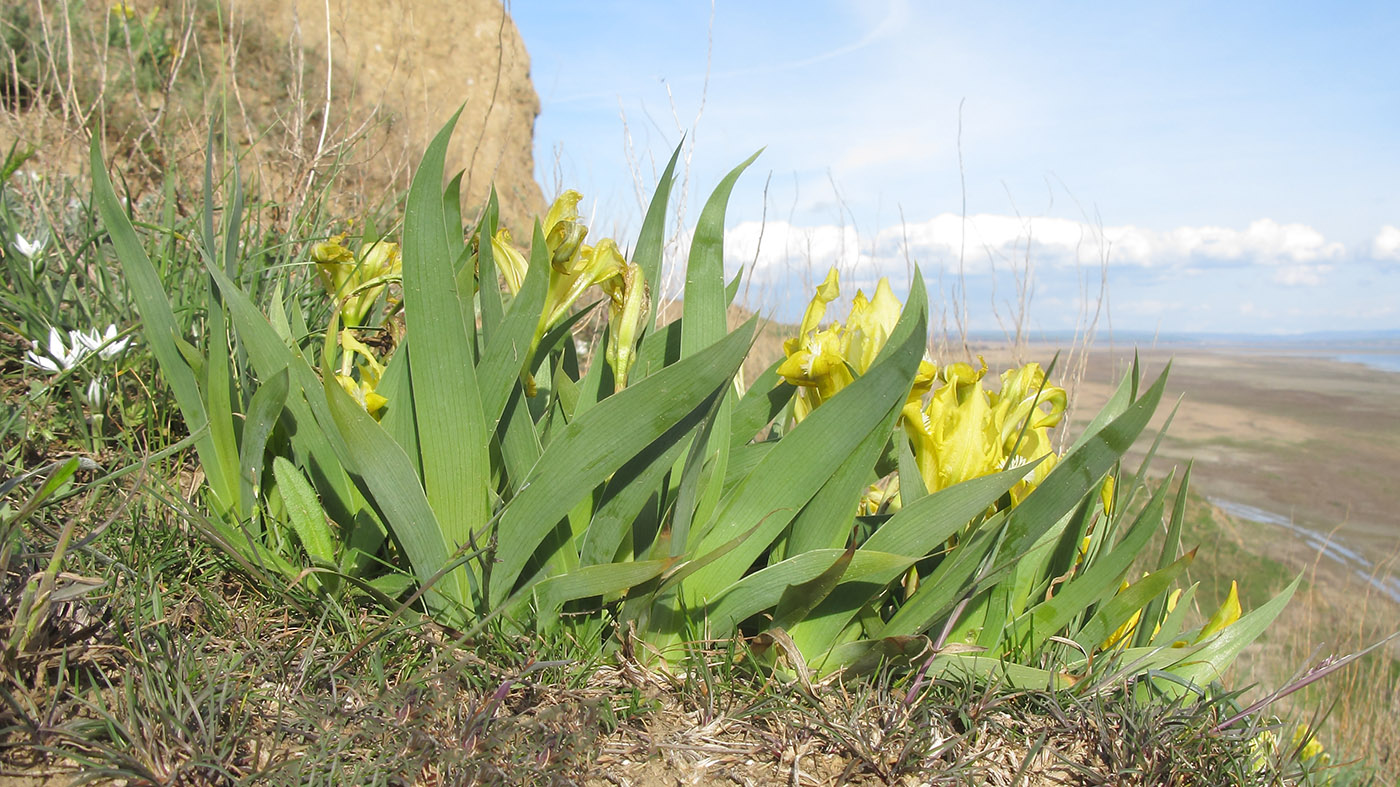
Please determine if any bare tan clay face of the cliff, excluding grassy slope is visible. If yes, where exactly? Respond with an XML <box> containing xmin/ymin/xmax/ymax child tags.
<box><xmin>234</xmin><ymin>0</ymin><xmax>543</xmax><ymax>227</ymax></box>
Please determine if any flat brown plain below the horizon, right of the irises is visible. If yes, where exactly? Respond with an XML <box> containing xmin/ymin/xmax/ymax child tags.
<box><xmin>1074</xmin><ymin>349</ymin><xmax>1400</xmax><ymax>562</ymax></box>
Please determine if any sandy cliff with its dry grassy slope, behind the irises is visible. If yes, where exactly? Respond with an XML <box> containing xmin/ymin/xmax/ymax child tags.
<box><xmin>0</xmin><ymin>0</ymin><xmax>543</xmax><ymax>227</ymax></box>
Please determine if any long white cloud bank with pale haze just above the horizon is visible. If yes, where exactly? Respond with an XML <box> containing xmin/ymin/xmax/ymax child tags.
<box><xmin>711</xmin><ymin>213</ymin><xmax>1400</xmax><ymax>335</ymax></box>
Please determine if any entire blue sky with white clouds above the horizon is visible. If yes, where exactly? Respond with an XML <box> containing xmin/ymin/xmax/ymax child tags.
<box><xmin>511</xmin><ymin>0</ymin><xmax>1400</xmax><ymax>333</ymax></box>
